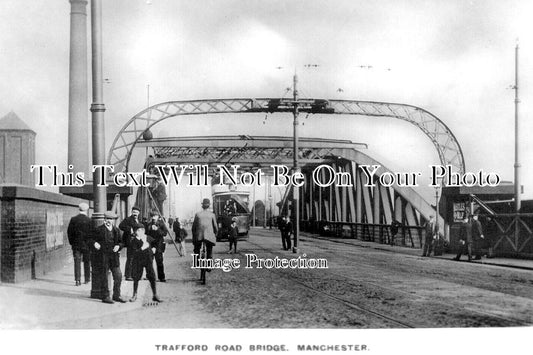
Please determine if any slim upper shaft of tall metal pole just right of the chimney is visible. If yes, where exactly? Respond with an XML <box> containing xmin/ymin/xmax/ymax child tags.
<box><xmin>91</xmin><ymin>0</ymin><xmax>107</xmax><ymax>224</ymax></box>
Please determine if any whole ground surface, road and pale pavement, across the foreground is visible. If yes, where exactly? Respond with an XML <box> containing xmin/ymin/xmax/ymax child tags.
<box><xmin>0</xmin><ymin>228</ymin><xmax>533</xmax><ymax>329</ymax></box>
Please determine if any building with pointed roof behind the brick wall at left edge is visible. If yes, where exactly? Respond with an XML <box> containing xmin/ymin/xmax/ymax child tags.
<box><xmin>0</xmin><ymin>111</ymin><xmax>35</xmax><ymax>186</ymax></box>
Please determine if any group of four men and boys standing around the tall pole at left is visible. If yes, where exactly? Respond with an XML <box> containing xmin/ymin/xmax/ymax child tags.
<box><xmin>67</xmin><ymin>203</ymin><xmax>168</xmax><ymax>304</ymax></box>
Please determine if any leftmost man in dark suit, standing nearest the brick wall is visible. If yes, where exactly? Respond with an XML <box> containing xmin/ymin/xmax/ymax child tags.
<box><xmin>67</xmin><ymin>202</ymin><xmax>93</xmax><ymax>286</ymax></box>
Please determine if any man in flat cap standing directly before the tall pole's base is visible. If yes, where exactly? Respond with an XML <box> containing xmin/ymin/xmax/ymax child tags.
<box><xmin>91</xmin><ymin>212</ymin><xmax>126</xmax><ymax>303</ymax></box>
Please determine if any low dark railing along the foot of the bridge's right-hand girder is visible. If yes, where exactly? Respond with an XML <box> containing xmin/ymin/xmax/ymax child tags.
<box><xmin>300</xmin><ymin>220</ymin><xmax>425</xmax><ymax>248</ymax></box>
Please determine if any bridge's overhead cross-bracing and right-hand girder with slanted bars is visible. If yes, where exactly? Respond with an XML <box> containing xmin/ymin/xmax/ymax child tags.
<box><xmin>139</xmin><ymin>136</ymin><xmax>445</xmax><ymax>236</ymax></box>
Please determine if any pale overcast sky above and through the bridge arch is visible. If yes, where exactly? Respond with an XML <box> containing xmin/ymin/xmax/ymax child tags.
<box><xmin>0</xmin><ymin>0</ymin><xmax>533</xmax><ymax>211</ymax></box>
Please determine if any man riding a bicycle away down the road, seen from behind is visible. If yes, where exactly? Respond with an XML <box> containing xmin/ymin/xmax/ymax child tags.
<box><xmin>192</xmin><ymin>198</ymin><xmax>218</xmax><ymax>268</ymax></box>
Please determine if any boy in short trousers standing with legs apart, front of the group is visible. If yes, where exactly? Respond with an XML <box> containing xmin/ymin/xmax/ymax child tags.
<box><xmin>130</xmin><ymin>223</ymin><xmax>162</xmax><ymax>302</ymax></box>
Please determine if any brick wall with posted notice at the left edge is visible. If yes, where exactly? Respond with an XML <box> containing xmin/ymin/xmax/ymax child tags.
<box><xmin>0</xmin><ymin>185</ymin><xmax>88</xmax><ymax>283</ymax></box>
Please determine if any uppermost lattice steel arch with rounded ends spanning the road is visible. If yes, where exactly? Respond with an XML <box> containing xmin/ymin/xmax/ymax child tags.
<box><xmin>107</xmin><ymin>98</ymin><xmax>465</xmax><ymax>173</ymax></box>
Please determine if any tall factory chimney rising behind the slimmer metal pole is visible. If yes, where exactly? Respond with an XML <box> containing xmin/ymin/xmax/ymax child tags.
<box><xmin>67</xmin><ymin>0</ymin><xmax>91</xmax><ymax>177</ymax></box>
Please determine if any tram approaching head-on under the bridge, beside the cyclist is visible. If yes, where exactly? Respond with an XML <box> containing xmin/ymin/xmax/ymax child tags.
<box><xmin>212</xmin><ymin>185</ymin><xmax>251</xmax><ymax>241</ymax></box>
